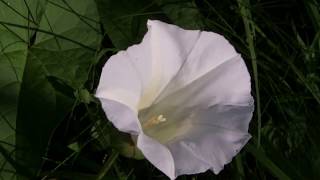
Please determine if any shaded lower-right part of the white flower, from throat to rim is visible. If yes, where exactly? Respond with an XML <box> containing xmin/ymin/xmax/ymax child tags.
<box><xmin>146</xmin><ymin>104</ymin><xmax>254</xmax><ymax>176</ymax></box>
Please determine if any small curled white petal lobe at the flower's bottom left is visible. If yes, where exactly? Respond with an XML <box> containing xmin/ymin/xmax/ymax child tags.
<box><xmin>137</xmin><ymin>133</ymin><xmax>176</xmax><ymax>179</ymax></box>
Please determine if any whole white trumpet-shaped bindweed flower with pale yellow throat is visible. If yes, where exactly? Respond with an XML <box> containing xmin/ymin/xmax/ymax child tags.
<box><xmin>96</xmin><ymin>20</ymin><xmax>254</xmax><ymax>179</ymax></box>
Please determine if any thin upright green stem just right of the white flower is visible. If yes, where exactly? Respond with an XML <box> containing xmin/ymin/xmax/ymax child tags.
<box><xmin>237</xmin><ymin>0</ymin><xmax>261</xmax><ymax>148</ymax></box>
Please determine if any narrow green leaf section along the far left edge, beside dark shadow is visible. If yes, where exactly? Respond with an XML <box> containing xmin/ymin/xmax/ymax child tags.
<box><xmin>0</xmin><ymin>50</ymin><xmax>26</xmax><ymax>178</ymax></box>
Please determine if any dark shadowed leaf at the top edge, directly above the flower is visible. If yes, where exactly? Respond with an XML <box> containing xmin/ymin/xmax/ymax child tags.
<box><xmin>96</xmin><ymin>0</ymin><xmax>165</xmax><ymax>49</ymax></box>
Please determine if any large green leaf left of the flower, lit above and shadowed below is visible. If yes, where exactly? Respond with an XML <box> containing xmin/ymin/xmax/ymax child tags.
<box><xmin>17</xmin><ymin>0</ymin><xmax>100</xmax><ymax>177</ymax></box>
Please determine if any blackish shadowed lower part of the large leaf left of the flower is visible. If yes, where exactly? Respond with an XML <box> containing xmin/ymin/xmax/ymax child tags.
<box><xmin>16</xmin><ymin>51</ymin><xmax>72</xmax><ymax>177</ymax></box>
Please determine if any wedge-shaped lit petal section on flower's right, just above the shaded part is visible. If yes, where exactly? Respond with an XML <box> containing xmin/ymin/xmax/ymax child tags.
<box><xmin>153</xmin><ymin>56</ymin><xmax>253</xmax><ymax>112</ymax></box>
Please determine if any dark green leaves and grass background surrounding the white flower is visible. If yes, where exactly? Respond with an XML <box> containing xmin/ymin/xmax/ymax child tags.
<box><xmin>0</xmin><ymin>0</ymin><xmax>320</xmax><ymax>180</ymax></box>
